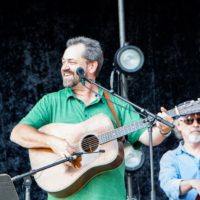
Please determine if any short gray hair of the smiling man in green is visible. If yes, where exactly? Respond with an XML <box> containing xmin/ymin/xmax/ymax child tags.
<box><xmin>66</xmin><ymin>36</ymin><xmax>104</xmax><ymax>75</ymax></box>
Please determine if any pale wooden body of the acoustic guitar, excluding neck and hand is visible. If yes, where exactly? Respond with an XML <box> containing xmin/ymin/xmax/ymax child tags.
<box><xmin>29</xmin><ymin>114</ymin><xmax>124</xmax><ymax>197</ymax></box>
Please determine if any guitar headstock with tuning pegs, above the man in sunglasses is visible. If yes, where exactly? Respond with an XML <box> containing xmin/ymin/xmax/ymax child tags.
<box><xmin>172</xmin><ymin>98</ymin><xmax>200</xmax><ymax>117</ymax></box>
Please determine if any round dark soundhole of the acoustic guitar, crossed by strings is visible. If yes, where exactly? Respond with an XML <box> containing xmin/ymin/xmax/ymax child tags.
<box><xmin>81</xmin><ymin>135</ymin><xmax>99</xmax><ymax>153</ymax></box>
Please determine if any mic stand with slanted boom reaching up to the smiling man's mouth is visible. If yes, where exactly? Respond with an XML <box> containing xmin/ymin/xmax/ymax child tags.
<box><xmin>80</xmin><ymin>76</ymin><xmax>174</xmax><ymax>200</ymax></box>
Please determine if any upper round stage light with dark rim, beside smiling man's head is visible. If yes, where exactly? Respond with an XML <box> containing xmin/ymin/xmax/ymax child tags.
<box><xmin>114</xmin><ymin>44</ymin><xmax>144</xmax><ymax>73</ymax></box>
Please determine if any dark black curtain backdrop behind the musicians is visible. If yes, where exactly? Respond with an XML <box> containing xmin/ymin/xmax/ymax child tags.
<box><xmin>0</xmin><ymin>0</ymin><xmax>200</xmax><ymax>200</ymax></box>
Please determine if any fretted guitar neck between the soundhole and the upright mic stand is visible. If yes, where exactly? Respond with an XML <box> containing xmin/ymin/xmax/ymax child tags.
<box><xmin>98</xmin><ymin>119</ymin><xmax>148</xmax><ymax>144</ymax></box>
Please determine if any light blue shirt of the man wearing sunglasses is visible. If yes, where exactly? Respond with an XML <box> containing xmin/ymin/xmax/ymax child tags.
<box><xmin>159</xmin><ymin>141</ymin><xmax>200</xmax><ymax>200</ymax></box>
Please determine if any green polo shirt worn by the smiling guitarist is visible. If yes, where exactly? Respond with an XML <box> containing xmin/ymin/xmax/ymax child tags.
<box><xmin>20</xmin><ymin>88</ymin><xmax>143</xmax><ymax>200</ymax></box>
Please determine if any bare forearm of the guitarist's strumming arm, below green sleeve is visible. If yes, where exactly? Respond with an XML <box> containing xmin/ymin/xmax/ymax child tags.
<box><xmin>10</xmin><ymin>124</ymin><xmax>53</xmax><ymax>148</ymax></box>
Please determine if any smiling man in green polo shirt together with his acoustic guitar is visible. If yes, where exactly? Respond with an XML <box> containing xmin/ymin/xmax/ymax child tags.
<box><xmin>11</xmin><ymin>37</ymin><xmax>173</xmax><ymax>200</ymax></box>
